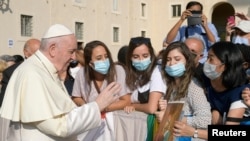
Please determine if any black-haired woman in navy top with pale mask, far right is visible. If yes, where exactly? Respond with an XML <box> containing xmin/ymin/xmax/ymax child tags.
<box><xmin>203</xmin><ymin>42</ymin><xmax>250</xmax><ymax>125</ymax></box>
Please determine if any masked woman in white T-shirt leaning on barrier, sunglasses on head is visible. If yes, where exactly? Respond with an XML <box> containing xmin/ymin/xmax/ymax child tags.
<box><xmin>125</xmin><ymin>37</ymin><xmax>166</xmax><ymax>114</ymax></box>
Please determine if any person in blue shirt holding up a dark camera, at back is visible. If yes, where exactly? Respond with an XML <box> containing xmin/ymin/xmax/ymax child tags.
<box><xmin>163</xmin><ymin>1</ymin><xmax>220</xmax><ymax>63</ymax></box>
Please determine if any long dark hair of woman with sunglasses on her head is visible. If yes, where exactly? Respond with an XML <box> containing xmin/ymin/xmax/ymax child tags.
<box><xmin>126</xmin><ymin>37</ymin><xmax>156</xmax><ymax>90</ymax></box>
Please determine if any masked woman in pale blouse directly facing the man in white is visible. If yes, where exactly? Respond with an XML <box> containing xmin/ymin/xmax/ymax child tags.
<box><xmin>72</xmin><ymin>41</ymin><xmax>130</xmax><ymax>141</ymax></box>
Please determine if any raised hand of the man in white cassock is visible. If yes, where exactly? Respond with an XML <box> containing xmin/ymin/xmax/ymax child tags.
<box><xmin>96</xmin><ymin>82</ymin><xmax>121</xmax><ymax>111</ymax></box>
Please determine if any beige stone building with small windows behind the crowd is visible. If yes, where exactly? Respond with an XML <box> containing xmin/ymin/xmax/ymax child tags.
<box><xmin>0</xmin><ymin>0</ymin><xmax>250</xmax><ymax>60</ymax></box>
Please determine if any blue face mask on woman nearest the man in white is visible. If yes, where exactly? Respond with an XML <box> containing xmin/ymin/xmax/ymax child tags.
<box><xmin>93</xmin><ymin>59</ymin><xmax>110</xmax><ymax>74</ymax></box>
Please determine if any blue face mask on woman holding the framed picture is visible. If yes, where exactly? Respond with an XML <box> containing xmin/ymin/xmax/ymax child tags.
<box><xmin>165</xmin><ymin>62</ymin><xmax>186</xmax><ymax>77</ymax></box>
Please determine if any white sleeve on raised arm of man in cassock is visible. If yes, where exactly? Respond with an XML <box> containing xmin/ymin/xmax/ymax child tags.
<box><xmin>36</xmin><ymin>102</ymin><xmax>101</xmax><ymax>137</ymax></box>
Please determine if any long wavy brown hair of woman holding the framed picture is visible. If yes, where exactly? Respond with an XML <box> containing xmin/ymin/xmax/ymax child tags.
<box><xmin>161</xmin><ymin>41</ymin><xmax>195</xmax><ymax>100</ymax></box>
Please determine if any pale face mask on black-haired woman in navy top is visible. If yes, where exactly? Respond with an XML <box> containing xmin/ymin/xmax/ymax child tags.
<box><xmin>203</xmin><ymin>62</ymin><xmax>221</xmax><ymax>80</ymax></box>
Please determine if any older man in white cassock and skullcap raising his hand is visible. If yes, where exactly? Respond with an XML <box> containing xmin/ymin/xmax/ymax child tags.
<box><xmin>0</xmin><ymin>24</ymin><xmax>121</xmax><ymax>141</ymax></box>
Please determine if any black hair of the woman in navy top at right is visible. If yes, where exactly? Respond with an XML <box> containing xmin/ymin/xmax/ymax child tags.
<box><xmin>210</xmin><ymin>41</ymin><xmax>247</xmax><ymax>89</ymax></box>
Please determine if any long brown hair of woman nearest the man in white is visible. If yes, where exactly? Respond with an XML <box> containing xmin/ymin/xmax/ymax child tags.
<box><xmin>84</xmin><ymin>40</ymin><xmax>116</xmax><ymax>91</ymax></box>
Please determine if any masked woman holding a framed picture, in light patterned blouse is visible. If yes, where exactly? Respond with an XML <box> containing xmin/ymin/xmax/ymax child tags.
<box><xmin>156</xmin><ymin>41</ymin><xmax>211</xmax><ymax>140</ymax></box>
